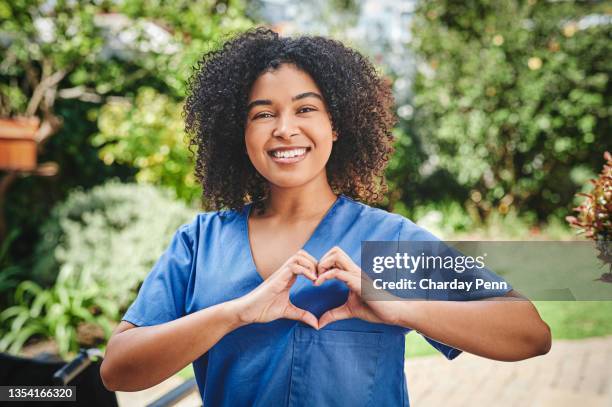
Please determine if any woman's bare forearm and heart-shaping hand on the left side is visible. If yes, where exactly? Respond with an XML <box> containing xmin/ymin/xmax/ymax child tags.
<box><xmin>100</xmin><ymin>250</ymin><xmax>318</xmax><ymax>391</ymax></box>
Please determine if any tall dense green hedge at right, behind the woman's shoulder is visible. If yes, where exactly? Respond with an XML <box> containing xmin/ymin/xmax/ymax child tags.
<box><xmin>400</xmin><ymin>0</ymin><xmax>612</xmax><ymax>219</ymax></box>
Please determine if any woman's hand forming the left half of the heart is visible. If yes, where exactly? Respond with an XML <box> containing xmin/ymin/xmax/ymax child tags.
<box><xmin>235</xmin><ymin>250</ymin><xmax>319</xmax><ymax>329</ymax></box>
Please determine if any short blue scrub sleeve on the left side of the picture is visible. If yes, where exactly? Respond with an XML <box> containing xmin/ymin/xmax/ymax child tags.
<box><xmin>122</xmin><ymin>223</ymin><xmax>194</xmax><ymax>326</ymax></box>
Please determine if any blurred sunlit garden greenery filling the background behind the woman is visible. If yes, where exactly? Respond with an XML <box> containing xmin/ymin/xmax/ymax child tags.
<box><xmin>0</xmin><ymin>0</ymin><xmax>612</xmax><ymax>405</ymax></box>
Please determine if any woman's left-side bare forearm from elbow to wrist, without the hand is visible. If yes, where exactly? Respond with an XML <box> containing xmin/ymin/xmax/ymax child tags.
<box><xmin>100</xmin><ymin>301</ymin><xmax>243</xmax><ymax>391</ymax></box>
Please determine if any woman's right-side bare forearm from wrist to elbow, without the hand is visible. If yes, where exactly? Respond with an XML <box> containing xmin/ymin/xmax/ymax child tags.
<box><xmin>396</xmin><ymin>291</ymin><xmax>551</xmax><ymax>361</ymax></box>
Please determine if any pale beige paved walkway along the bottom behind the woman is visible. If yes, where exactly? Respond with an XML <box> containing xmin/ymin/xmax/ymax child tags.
<box><xmin>118</xmin><ymin>337</ymin><xmax>612</xmax><ymax>407</ymax></box>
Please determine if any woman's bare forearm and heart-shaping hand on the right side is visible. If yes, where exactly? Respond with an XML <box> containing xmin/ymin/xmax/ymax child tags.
<box><xmin>315</xmin><ymin>246</ymin><xmax>551</xmax><ymax>361</ymax></box>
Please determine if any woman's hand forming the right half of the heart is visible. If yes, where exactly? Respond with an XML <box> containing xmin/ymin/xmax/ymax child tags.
<box><xmin>314</xmin><ymin>246</ymin><xmax>405</xmax><ymax>329</ymax></box>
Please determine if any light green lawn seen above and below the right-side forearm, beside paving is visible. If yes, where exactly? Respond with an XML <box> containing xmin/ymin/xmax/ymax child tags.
<box><xmin>406</xmin><ymin>301</ymin><xmax>612</xmax><ymax>358</ymax></box>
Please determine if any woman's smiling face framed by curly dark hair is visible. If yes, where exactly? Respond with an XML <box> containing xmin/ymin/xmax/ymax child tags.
<box><xmin>245</xmin><ymin>64</ymin><xmax>336</xmax><ymax>188</ymax></box>
